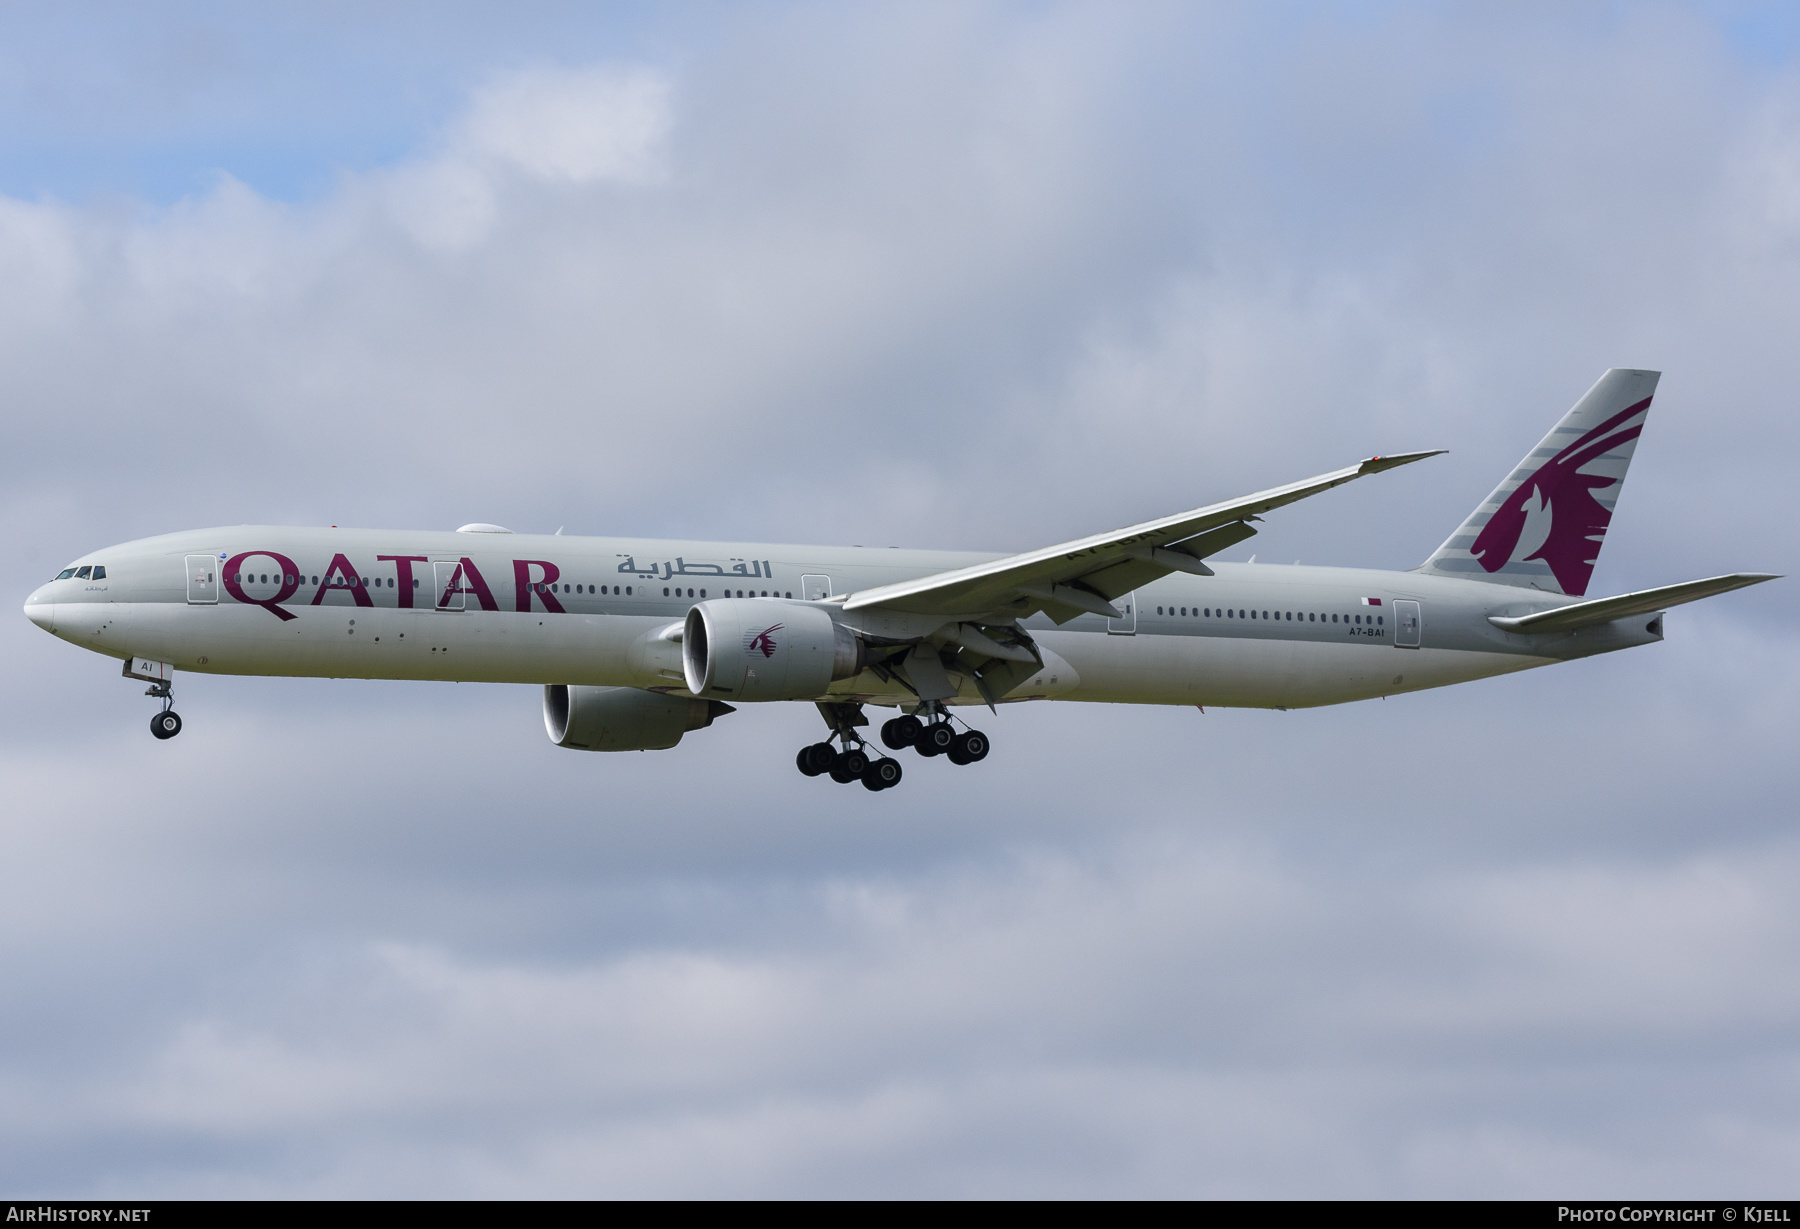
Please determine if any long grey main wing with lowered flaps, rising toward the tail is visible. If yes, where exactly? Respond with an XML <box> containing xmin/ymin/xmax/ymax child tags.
<box><xmin>844</xmin><ymin>448</ymin><xmax>1444</xmax><ymax>623</ymax></box>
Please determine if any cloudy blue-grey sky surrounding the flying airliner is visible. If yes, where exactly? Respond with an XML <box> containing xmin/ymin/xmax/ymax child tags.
<box><xmin>0</xmin><ymin>4</ymin><xmax>1800</xmax><ymax>1197</ymax></box>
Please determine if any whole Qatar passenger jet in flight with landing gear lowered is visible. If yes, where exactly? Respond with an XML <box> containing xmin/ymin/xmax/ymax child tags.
<box><xmin>25</xmin><ymin>369</ymin><xmax>1775</xmax><ymax>790</ymax></box>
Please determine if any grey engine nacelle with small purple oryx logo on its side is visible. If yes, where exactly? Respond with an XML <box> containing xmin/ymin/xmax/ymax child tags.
<box><xmin>680</xmin><ymin>597</ymin><xmax>866</xmax><ymax>700</ymax></box>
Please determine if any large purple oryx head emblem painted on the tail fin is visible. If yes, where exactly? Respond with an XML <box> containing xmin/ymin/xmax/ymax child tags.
<box><xmin>1469</xmin><ymin>398</ymin><xmax>1651</xmax><ymax>597</ymax></box>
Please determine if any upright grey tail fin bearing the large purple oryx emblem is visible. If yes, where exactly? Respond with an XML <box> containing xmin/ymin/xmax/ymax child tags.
<box><xmin>1418</xmin><ymin>367</ymin><xmax>1661</xmax><ymax>597</ymax></box>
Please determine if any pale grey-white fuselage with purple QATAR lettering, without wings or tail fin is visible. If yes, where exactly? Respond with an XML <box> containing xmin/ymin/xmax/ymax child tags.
<box><xmin>25</xmin><ymin>525</ymin><xmax>1660</xmax><ymax>707</ymax></box>
